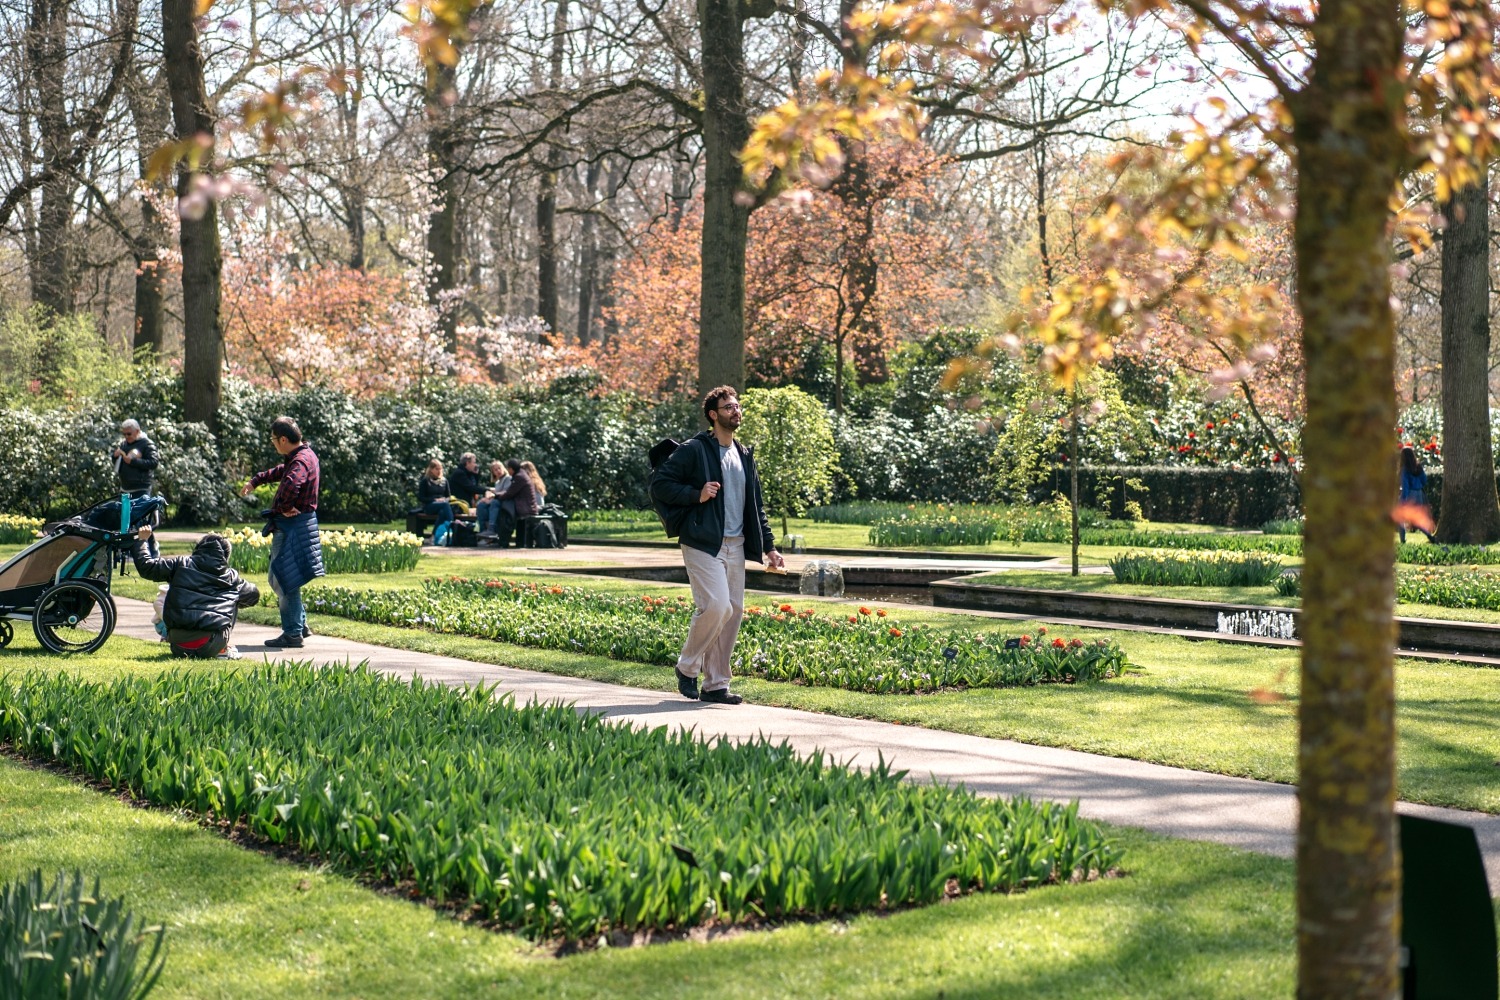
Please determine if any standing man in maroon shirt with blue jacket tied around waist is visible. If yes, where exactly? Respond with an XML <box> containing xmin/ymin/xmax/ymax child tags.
<box><xmin>240</xmin><ymin>417</ymin><xmax>323</xmax><ymax>649</ymax></box>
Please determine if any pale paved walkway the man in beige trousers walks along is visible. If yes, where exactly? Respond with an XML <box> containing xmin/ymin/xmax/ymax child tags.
<box><xmin>116</xmin><ymin>598</ymin><xmax>1500</xmax><ymax>895</ymax></box>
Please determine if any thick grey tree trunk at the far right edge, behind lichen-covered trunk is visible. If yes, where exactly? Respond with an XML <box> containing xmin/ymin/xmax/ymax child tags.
<box><xmin>1436</xmin><ymin>168</ymin><xmax>1500</xmax><ymax>546</ymax></box>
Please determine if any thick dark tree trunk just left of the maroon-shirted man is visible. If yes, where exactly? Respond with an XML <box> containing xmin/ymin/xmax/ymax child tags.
<box><xmin>162</xmin><ymin>0</ymin><xmax>224</xmax><ymax>429</ymax></box>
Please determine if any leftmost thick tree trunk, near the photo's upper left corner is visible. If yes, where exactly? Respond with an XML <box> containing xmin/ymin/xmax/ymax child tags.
<box><xmin>26</xmin><ymin>0</ymin><xmax>78</xmax><ymax>325</ymax></box>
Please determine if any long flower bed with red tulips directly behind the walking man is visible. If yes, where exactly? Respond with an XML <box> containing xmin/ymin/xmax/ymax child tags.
<box><xmin>306</xmin><ymin>579</ymin><xmax>1128</xmax><ymax>694</ymax></box>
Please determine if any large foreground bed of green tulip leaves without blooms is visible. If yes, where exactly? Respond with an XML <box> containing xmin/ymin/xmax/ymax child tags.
<box><xmin>0</xmin><ymin>663</ymin><xmax>1121</xmax><ymax>940</ymax></box>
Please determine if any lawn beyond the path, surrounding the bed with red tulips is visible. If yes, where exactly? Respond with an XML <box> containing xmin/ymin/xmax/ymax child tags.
<box><xmin>96</xmin><ymin>555</ymin><xmax>1500</xmax><ymax>813</ymax></box>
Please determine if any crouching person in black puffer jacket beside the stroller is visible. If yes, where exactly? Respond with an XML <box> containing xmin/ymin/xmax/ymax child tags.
<box><xmin>134</xmin><ymin>528</ymin><xmax>261</xmax><ymax>660</ymax></box>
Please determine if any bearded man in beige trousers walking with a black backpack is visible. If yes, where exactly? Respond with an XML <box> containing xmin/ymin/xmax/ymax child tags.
<box><xmin>651</xmin><ymin>385</ymin><xmax>785</xmax><ymax>705</ymax></box>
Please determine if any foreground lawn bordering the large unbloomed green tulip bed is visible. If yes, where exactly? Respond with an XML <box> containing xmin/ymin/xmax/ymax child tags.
<box><xmin>0</xmin><ymin>637</ymin><xmax>1314</xmax><ymax>999</ymax></box>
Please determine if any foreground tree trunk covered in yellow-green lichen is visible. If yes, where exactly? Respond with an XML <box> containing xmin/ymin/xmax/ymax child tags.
<box><xmin>1292</xmin><ymin>0</ymin><xmax>1406</xmax><ymax>1000</ymax></box>
